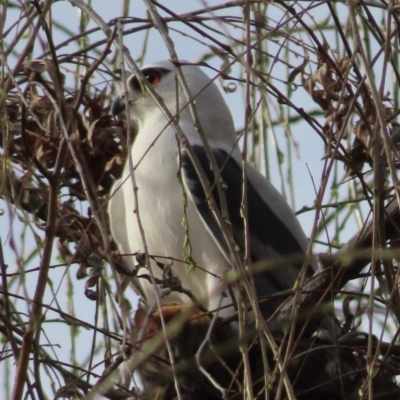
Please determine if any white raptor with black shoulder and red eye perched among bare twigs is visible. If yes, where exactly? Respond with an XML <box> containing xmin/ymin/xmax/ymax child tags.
<box><xmin>109</xmin><ymin>61</ymin><xmax>315</xmax><ymax>394</ymax></box>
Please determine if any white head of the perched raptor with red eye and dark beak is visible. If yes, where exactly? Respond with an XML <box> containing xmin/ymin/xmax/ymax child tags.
<box><xmin>112</xmin><ymin>60</ymin><xmax>234</xmax><ymax>139</ymax></box>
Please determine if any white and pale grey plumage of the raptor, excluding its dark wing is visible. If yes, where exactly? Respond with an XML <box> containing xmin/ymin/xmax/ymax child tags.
<box><xmin>109</xmin><ymin>61</ymin><xmax>307</xmax><ymax>317</ymax></box>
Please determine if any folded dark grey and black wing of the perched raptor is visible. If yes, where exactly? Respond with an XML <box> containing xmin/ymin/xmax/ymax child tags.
<box><xmin>182</xmin><ymin>145</ymin><xmax>315</xmax><ymax>313</ymax></box>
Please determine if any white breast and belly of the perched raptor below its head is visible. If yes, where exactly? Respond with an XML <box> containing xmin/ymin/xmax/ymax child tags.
<box><xmin>109</xmin><ymin>119</ymin><xmax>232</xmax><ymax>317</ymax></box>
